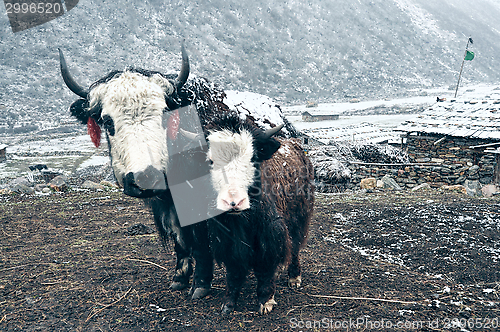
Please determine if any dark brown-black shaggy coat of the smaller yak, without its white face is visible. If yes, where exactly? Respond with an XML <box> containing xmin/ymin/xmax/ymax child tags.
<box><xmin>208</xmin><ymin>116</ymin><xmax>314</xmax><ymax>314</ymax></box>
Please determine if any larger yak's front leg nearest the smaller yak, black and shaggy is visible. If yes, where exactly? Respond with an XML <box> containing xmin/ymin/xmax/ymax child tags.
<box><xmin>190</xmin><ymin>221</ymin><xmax>214</xmax><ymax>300</ymax></box>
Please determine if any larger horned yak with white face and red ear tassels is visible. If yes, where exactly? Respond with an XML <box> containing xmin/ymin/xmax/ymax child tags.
<box><xmin>59</xmin><ymin>47</ymin><xmax>229</xmax><ymax>298</ymax></box>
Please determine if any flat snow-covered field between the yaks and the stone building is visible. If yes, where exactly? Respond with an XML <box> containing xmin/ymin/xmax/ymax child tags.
<box><xmin>284</xmin><ymin>85</ymin><xmax>497</xmax><ymax>143</ymax></box>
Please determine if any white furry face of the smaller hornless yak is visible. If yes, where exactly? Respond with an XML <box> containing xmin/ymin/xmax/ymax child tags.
<box><xmin>207</xmin><ymin>130</ymin><xmax>255</xmax><ymax>211</ymax></box>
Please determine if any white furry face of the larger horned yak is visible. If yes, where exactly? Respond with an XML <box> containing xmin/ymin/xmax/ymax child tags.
<box><xmin>89</xmin><ymin>71</ymin><xmax>174</xmax><ymax>183</ymax></box>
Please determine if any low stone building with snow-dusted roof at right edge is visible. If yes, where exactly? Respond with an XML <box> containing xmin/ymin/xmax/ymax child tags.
<box><xmin>398</xmin><ymin>93</ymin><xmax>500</xmax><ymax>186</ymax></box>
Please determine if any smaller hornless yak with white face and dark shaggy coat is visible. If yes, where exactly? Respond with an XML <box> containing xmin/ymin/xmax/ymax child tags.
<box><xmin>207</xmin><ymin>116</ymin><xmax>314</xmax><ymax>314</ymax></box>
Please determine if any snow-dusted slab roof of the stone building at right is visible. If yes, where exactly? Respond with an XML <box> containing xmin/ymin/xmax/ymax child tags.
<box><xmin>397</xmin><ymin>88</ymin><xmax>500</xmax><ymax>141</ymax></box>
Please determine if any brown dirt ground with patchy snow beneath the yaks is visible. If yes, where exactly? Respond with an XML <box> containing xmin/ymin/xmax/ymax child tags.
<box><xmin>0</xmin><ymin>190</ymin><xmax>500</xmax><ymax>331</ymax></box>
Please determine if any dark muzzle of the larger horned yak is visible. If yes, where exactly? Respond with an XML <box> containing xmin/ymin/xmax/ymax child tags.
<box><xmin>123</xmin><ymin>166</ymin><xmax>167</xmax><ymax>198</ymax></box>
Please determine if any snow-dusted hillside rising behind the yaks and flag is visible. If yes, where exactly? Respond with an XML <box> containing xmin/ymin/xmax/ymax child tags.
<box><xmin>0</xmin><ymin>0</ymin><xmax>500</xmax><ymax>134</ymax></box>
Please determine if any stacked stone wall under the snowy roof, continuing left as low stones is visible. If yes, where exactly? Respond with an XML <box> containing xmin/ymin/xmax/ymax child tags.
<box><xmin>346</xmin><ymin>136</ymin><xmax>500</xmax><ymax>188</ymax></box>
